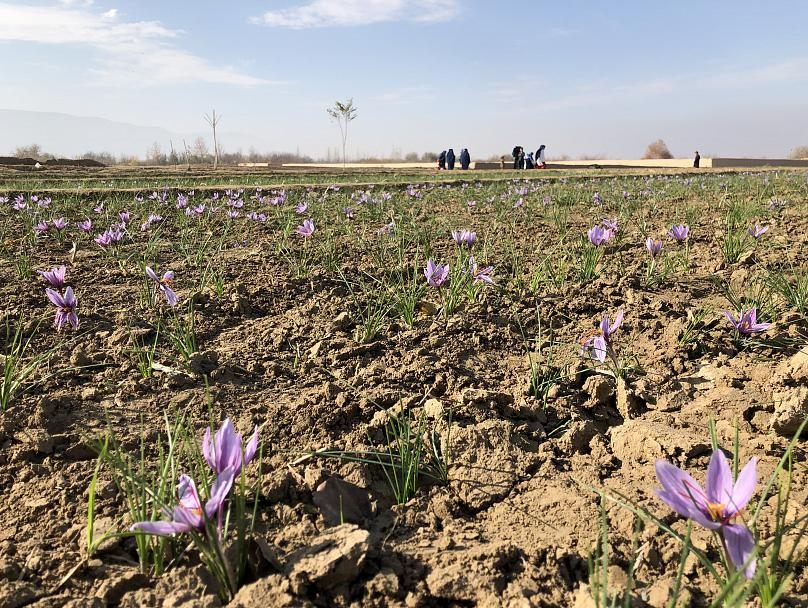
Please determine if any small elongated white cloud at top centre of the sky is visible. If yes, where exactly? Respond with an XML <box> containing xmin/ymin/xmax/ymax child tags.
<box><xmin>250</xmin><ymin>0</ymin><xmax>460</xmax><ymax>29</ymax></box>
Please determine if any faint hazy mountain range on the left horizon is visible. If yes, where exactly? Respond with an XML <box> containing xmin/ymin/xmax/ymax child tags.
<box><xmin>0</xmin><ymin>109</ymin><xmax>256</xmax><ymax>158</ymax></box>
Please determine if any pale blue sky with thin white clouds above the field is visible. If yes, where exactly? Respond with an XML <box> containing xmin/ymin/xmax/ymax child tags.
<box><xmin>0</xmin><ymin>0</ymin><xmax>808</xmax><ymax>158</ymax></box>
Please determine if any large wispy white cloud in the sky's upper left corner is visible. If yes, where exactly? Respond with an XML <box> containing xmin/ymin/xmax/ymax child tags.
<box><xmin>0</xmin><ymin>0</ymin><xmax>269</xmax><ymax>87</ymax></box>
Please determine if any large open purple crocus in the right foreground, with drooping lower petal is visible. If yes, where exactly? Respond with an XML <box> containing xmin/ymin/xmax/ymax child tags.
<box><xmin>656</xmin><ymin>450</ymin><xmax>757</xmax><ymax>578</ymax></box>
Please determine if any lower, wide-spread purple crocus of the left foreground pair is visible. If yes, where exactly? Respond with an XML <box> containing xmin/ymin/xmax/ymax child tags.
<box><xmin>129</xmin><ymin>469</ymin><xmax>236</xmax><ymax>536</ymax></box>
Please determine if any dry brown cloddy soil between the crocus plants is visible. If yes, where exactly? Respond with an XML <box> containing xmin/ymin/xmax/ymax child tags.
<box><xmin>0</xmin><ymin>172</ymin><xmax>808</xmax><ymax>608</ymax></box>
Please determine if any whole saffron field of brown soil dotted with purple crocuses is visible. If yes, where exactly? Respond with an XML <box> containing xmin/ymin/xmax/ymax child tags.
<box><xmin>0</xmin><ymin>169</ymin><xmax>808</xmax><ymax>608</ymax></box>
